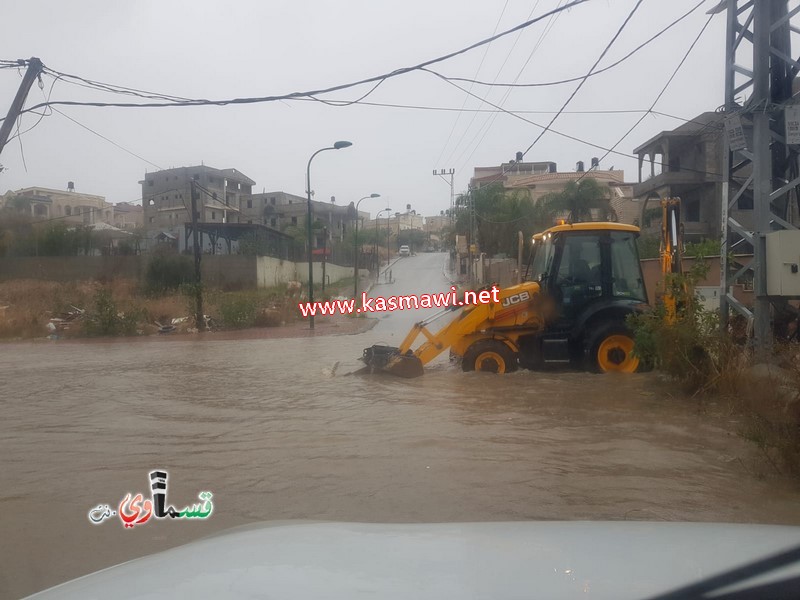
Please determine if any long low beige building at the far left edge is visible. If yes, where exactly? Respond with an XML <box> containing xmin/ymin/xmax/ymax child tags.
<box><xmin>0</xmin><ymin>181</ymin><xmax>114</xmax><ymax>225</ymax></box>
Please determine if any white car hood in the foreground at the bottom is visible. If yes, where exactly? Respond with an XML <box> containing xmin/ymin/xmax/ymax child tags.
<box><xmin>32</xmin><ymin>521</ymin><xmax>800</xmax><ymax>600</ymax></box>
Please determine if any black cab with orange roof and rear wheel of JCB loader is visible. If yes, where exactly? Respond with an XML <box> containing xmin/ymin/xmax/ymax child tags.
<box><xmin>518</xmin><ymin>223</ymin><xmax>647</xmax><ymax>372</ymax></box>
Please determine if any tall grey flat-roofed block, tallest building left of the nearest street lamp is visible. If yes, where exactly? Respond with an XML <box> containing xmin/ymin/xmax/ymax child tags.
<box><xmin>139</xmin><ymin>165</ymin><xmax>255</xmax><ymax>247</ymax></box>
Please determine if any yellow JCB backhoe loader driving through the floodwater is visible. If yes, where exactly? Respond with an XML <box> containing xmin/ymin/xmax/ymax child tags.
<box><xmin>362</xmin><ymin>223</ymin><xmax>647</xmax><ymax>377</ymax></box>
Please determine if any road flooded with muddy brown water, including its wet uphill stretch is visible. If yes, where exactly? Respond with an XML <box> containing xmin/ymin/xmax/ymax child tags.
<box><xmin>0</xmin><ymin>254</ymin><xmax>800</xmax><ymax>598</ymax></box>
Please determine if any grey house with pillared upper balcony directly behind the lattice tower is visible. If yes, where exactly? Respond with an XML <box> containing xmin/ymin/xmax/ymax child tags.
<box><xmin>633</xmin><ymin>112</ymin><xmax>736</xmax><ymax>241</ymax></box>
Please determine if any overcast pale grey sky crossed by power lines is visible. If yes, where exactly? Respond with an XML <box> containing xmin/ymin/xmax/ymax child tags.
<box><xmin>0</xmin><ymin>0</ymin><xmax>725</xmax><ymax>215</ymax></box>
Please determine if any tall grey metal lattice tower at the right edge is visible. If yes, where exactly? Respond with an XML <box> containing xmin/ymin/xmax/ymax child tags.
<box><xmin>710</xmin><ymin>0</ymin><xmax>800</xmax><ymax>356</ymax></box>
